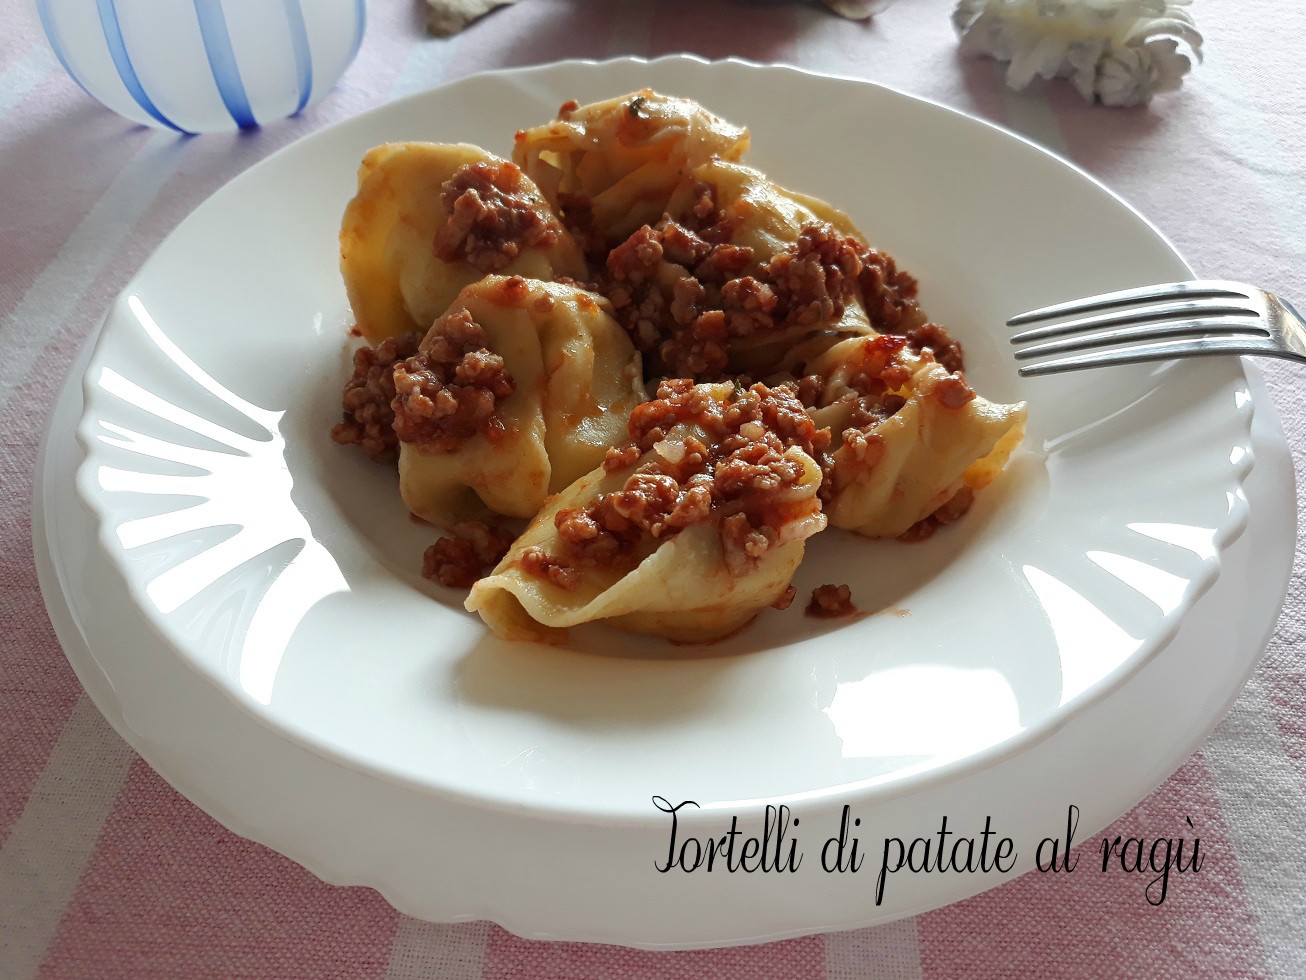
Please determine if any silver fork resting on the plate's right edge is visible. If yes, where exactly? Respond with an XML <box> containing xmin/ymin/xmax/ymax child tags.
<box><xmin>1007</xmin><ymin>280</ymin><xmax>1306</xmax><ymax>378</ymax></box>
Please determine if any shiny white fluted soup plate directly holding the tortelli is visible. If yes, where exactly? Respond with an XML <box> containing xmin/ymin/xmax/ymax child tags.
<box><xmin>48</xmin><ymin>59</ymin><xmax>1285</xmax><ymax>943</ymax></box>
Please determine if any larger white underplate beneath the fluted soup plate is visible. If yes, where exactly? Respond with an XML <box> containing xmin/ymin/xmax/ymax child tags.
<box><xmin>33</xmin><ymin>337</ymin><xmax>1296</xmax><ymax>949</ymax></box>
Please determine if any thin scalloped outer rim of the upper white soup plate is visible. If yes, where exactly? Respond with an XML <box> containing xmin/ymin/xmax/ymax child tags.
<box><xmin>68</xmin><ymin>54</ymin><xmax>1255</xmax><ymax>826</ymax></box>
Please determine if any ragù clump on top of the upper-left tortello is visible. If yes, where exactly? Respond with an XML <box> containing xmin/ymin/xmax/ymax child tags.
<box><xmin>434</xmin><ymin>161</ymin><xmax>562</xmax><ymax>272</ymax></box>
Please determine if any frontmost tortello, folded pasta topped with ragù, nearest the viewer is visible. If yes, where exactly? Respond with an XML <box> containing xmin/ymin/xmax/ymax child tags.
<box><xmin>466</xmin><ymin>384</ymin><xmax>825</xmax><ymax>643</ymax></box>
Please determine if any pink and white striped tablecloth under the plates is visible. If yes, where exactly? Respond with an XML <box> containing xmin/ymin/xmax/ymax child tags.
<box><xmin>0</xmin><ymin>0</ymin><xmax>1306</xmax><ymax>979</ymax></box>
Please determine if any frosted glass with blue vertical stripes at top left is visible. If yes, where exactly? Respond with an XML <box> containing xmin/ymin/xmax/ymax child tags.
<box><xmin>30</xmin><ymin>0</ymin><xmax>367</xmax><ymax>133</ymax></box>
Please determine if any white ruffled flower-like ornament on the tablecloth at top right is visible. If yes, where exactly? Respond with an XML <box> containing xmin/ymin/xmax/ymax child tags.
<box><xmin>952</xmin><ymin>0</ymin><xmax>1202</xmax><ymax>106</ymax></box>
